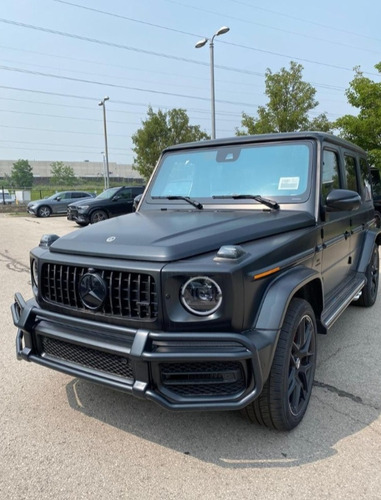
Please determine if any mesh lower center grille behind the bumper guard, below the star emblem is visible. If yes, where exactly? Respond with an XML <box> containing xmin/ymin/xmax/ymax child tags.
<box><xmin>40</xmin><ymin>336</ymin><xmax>134</xmax><ymax>379</ymax></box>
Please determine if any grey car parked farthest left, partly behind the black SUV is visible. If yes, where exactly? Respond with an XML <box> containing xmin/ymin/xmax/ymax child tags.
<box><xmin>27</xmin><ymin>191</ymin><xmax>94</xmax><ymax>217</ymax></box>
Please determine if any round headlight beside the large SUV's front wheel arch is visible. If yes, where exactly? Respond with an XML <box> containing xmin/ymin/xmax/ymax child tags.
<box><xmin>181</xmin><ymin>276</ymin><xmax>222</xmax><ymax>316</ymax></box>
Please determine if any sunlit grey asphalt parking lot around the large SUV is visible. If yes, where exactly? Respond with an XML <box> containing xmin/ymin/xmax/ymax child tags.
<box><xmin>0</xmin><ymin>214</ymin><xmax>381</xmax><ymax>500</ymax></box>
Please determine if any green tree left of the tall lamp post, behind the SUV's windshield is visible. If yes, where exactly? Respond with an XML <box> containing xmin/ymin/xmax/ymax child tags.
<box><xmin>132</xmin><ymin>106</ymin><xmax>209</xmax><ymax>179</ymax></box>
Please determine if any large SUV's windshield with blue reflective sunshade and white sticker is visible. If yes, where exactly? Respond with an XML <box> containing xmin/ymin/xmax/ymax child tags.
<box><xmin>150</xmin><ymin>141</ymin><xmax>311</xmax><ymax>203</ymax></box>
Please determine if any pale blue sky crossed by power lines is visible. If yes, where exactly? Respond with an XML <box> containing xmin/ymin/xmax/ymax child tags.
<box><xmin>0</xmin><ymin>0</ymin><xmax>381</xmax><ymax>163</ymax></box>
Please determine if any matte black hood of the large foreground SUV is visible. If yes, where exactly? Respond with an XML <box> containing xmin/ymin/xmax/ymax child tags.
<box><xmin>50</xmin><ymin>210</ymin><xmax>315</xmax><ymax>262</ymax></box>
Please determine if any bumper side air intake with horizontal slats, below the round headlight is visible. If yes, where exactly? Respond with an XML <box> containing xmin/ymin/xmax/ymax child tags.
<box><xmin>160</xmin><ymin>361</ymin><xmax>246</xmax><ymax>397</ymax></box>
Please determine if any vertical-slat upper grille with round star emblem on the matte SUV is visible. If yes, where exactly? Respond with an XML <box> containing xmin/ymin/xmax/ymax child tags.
<box><xmin>40</xmin><ymin>264</ymin><xmax>158</xmax><ymax>320</ymax></box>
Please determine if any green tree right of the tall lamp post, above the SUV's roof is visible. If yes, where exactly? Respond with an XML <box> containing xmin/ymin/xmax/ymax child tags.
<box><xmin>237</xmin><ymin>61</ymin><xmax>331</xmax><ymax>135</ymax></box>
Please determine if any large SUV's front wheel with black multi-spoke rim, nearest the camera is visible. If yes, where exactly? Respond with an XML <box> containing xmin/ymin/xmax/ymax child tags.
<box><xmin>242</xmin><ymin>298</ymin><xmax>317</xmax><ymax>431</ymax></box>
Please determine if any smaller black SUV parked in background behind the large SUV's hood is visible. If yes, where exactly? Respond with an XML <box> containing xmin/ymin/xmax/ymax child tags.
<box><xmin>67</xmin><ymin>186</ymin><xmax>144</xmax><ymax>226</ymax></box>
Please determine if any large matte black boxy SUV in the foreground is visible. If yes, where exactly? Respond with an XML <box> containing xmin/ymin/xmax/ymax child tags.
<box><xmin>12</xmin><ymin>132</ymin><xmax>381</xmax><ymax>430</ymax></box>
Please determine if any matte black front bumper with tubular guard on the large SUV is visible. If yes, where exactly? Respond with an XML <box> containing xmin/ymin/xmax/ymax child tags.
<box><xmin>12</xmin><ymin>293</ymin><xmax>277</xmax><ymax>410</ymax></box>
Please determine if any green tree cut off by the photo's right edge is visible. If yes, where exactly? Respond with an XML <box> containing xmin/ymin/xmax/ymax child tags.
<box><xmin>334</xmin><ymin>62</ymin><xmax>381</xmax><ymax>170</ymax></box>
